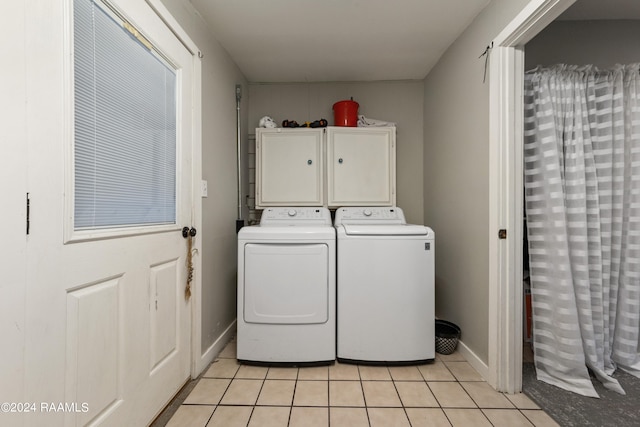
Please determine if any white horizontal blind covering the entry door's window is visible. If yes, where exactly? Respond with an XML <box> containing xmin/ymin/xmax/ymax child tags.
<box><xmin>74</xmin><ymin>0</ymin><xmax>176</xmax><ymax>230</ymax></box>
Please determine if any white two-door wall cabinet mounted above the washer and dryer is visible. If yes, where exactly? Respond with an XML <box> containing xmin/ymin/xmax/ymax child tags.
<box><xmin>256</xmin><ymin>126</ymin><xmax>396</xmax><ymax>209</ymax></box>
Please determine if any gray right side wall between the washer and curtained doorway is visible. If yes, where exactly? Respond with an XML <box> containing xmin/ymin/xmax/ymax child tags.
<box><xmin>424</xmin><ymin>0</ymin><xmax>528</xmax><ymax>363</ymax></box>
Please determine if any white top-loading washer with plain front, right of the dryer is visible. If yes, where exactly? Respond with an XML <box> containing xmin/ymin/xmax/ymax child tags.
<box><xmin>334</xmin><ymin>207</ymin><xmax>435</xmax><ymax>364</ymax></box>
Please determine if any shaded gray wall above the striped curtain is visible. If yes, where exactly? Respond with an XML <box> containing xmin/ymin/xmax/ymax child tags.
<box><xmin>525</xmin><ymin>20</ymin><xmax>640</xmax><ymax>70</ymax></box>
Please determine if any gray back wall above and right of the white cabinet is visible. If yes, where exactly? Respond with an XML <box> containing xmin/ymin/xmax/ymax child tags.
<box><xmin>248</xmin><ymin>81</ymin><xmax>424</xmax><ymax>223</ymax></box>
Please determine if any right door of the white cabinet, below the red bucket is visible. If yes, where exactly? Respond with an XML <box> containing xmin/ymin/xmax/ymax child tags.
<box><xmin>327</xmin><ymin>127</ymin><xmax>396</xmax><ymax>207</ymax></box>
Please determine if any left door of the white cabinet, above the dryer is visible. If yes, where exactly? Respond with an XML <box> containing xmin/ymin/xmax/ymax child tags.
<box><xmin>256</xmin><ymin>129</ymin><xmax>324</xmax><ymax>208</ymax></box>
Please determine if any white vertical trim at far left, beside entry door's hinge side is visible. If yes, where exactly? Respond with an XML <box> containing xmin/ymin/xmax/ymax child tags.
<box><xmin>0</xmin><ymin>1</ymin><xmax>29</xmax><ymax>408</ymax></box>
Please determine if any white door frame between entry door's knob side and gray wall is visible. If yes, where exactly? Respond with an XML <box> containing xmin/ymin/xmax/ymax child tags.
<box><xmin>145</xmin><ymin>0</ymin><xmax>205</xmax><ymax>378</ymax></box>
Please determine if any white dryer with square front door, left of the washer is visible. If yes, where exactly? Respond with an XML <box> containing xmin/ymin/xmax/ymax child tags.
<box><xmin>237</xmin><ymin>207</ymin><xmax>336</xmax><ymax>364</ymax></box>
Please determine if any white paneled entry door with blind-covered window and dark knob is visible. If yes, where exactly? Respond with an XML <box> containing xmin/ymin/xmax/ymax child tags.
<box><xmin>16</xmin><ymin>0</ymin><xmax>199</xmax><ymax>426</ymax></box>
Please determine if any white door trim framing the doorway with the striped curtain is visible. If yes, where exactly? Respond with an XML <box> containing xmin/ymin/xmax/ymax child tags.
<box><xmin>488</xmin><ymin>0</ymin><xmax>576</xmax><ymax>393</ymax></box>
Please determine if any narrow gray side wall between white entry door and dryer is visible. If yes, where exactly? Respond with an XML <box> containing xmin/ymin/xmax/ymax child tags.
<box><xmin>162</xmin><ymin>0</ymin><xmax>248</xmax><ymax>352</ymax></box>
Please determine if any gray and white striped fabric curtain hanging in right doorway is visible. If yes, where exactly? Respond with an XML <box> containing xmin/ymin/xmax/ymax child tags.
<box><xmin>524</xmin><ymin>64</ymin><xmax>640</xmax><ymax>397</ymax></box>
